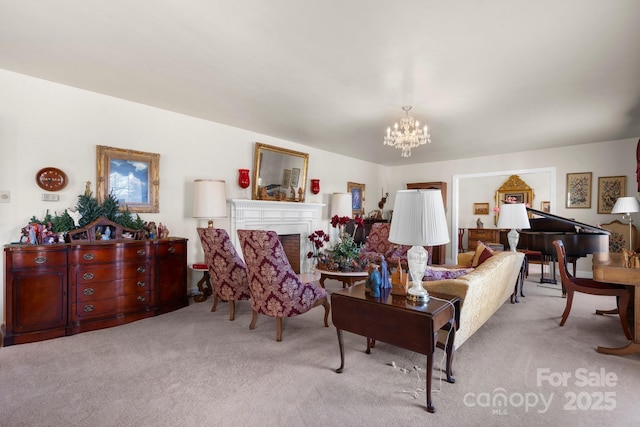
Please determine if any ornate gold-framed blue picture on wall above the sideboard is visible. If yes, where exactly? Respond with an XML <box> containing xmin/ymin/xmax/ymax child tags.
<box><xmin>96</xmin><ymin>145</ymin><xmax>160</xmax><ymax>213</ymax></box>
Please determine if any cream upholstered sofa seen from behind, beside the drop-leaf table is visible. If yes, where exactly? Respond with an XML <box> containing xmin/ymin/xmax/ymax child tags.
<box><xmin>423</xmin><ymin>252</ymin><xmax>524</xmax><ymax>348</ymax></box>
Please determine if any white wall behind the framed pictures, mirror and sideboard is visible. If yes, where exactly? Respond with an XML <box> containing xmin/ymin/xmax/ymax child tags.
<box><xmin>0</xmin><ymin>70</ymin><xmax>640</xmax><ymax>324</ymax></box>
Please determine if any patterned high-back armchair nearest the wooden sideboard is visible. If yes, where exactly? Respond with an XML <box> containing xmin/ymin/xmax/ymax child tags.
<box><xmin>198</xmin><ymin>228</ymin><xmax>251</xmax><ymax>320</ymax></box>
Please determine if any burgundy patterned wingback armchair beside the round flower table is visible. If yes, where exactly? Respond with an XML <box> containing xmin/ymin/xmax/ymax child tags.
<box><xmin>238</xmin><ymin>230</ymin><xmax>330</xmax><ymax>341</ymax></box>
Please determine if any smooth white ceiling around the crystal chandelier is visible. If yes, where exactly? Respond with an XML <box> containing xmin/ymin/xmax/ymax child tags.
<box><xmin>0</xmin><ymin>0</ymin><xmax>640</xmax><ymax>165</ymax></box>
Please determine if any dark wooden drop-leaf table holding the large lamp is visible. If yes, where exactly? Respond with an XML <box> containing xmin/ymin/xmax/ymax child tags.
<box><xmin>331</xmin><ymin>284</ymin><xmax>460</xmax><ymax>412</ymax></box>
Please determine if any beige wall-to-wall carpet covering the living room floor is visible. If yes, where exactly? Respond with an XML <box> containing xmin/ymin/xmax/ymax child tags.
<box><xmin>0</xmin><ymin>275</ymin><xmax>640</xmax><ymax>426</ymax></box>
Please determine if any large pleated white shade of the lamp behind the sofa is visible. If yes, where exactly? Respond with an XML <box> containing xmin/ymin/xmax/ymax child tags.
<box><xmin>389</xmin><ymin>190</ymin><xmax>450</xmax><ymax>246</ymax></box>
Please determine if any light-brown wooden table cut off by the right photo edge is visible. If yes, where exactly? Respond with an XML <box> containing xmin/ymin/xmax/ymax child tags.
<box><xmin>593</xmin><ymin>253</ymin><xmax>640</xmax><ymax>356</ymax></box>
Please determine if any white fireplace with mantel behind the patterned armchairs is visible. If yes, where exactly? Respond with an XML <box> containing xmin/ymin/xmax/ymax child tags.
<box><xmin>231</xmin><ymin>199</ymin><xmax>325</xmax><ymax>273</ymax></box>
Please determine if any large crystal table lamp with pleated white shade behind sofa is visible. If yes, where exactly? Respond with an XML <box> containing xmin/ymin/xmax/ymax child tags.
<box><xmin>389</xmin><ymin>190</ymin><xmax>449</xmax><ymax>302</ymax></box>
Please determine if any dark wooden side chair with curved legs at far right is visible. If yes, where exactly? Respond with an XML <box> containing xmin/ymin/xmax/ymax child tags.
<box><xmin>553</xmin><ymin>240</ymin><xmax>633</xmax><ymax>340</ymax></box>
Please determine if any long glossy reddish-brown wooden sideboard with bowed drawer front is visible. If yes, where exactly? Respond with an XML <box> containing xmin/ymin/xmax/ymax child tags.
<box><xmin>0</xmin><ymin>237</ymin><xmax>188</xmax><ymax>346</ymax></box>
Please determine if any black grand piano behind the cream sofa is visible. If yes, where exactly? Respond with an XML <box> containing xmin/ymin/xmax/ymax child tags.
<box><xmin>518</xmin><ymin>208</ymin><xmax>611</xmax><ymax>284</ymax></box>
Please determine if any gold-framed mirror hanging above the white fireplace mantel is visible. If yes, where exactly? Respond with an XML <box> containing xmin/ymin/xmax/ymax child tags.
<box><xmin>252</xmin><ymin>142</ymin><xmax>309</xmax><ymax>202</ymax></box>
